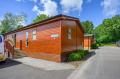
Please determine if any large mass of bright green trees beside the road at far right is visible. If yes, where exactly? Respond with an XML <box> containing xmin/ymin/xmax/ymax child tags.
<box><xmin>94</xmin><ymin>15</ymin><xmax>120</xmax><ymax>43</ymax></box>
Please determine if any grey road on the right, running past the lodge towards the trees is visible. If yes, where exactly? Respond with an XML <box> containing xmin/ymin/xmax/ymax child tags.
<box><xmin>68</xmin><ymin>47</ymin><xmax>120</xmax><ymax>79</ymax></box>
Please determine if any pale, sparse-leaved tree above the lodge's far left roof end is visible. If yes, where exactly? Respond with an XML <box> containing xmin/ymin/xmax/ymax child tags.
<box><xmin>0</xmin><ymin>13</ymin><xmax>25</xmax><ymax>34</ymax></box>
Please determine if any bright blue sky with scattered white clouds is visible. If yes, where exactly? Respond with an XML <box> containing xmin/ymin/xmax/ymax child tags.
<box><xmin>0</xmin><ymin>0</ymin><xmax>120</xmax><ymax>26</ymax></box>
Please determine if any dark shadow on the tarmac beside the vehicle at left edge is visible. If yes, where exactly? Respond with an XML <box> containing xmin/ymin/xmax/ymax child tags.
<box><xmin>0</xmin><ymin>59</ymin><xmax>21</xmax><ymax>69</ymax></box>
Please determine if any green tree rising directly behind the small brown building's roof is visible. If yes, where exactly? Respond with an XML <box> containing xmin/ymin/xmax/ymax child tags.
<box><xmin>82</xmin><ymin>21</ymin><xmax>94</xmax><ymax>34</ymax></box>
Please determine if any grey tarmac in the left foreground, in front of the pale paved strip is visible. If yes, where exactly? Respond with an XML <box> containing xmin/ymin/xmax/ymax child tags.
<box><xmin>0</xmin><ymin>61</ymin><xmax>73</xmax><ymax>79</ymax></box>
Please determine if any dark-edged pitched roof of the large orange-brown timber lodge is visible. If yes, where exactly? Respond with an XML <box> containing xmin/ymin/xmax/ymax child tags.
<box><xmin>4</xmin><ymin>14</ymin><xmax>84</xmax><ymax>35</ymax></box>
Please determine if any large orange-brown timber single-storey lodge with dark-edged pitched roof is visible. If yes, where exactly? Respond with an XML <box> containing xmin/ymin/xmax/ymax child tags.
<box><xmin>5</xmin><ymin>14</ymin><xmax>84</xmax><ymax>62</ymax></box>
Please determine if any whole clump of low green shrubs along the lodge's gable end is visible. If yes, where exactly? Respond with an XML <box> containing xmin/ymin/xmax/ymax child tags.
<box><xmin>68</xmin><ymin>50</ymin><xmax>88</xmax><ymax>61</ymax></box>
